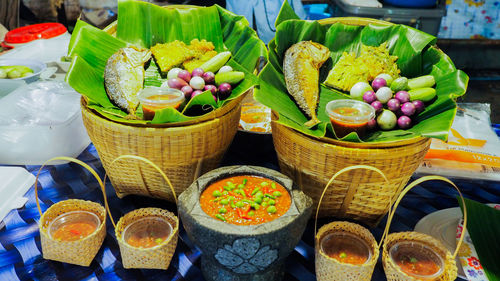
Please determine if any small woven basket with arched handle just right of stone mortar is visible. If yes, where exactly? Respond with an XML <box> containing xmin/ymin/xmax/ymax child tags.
<box><xmin>314</xmin><ymin>165</ymin><xmax>387</xmax><ymax>281</ymax></box>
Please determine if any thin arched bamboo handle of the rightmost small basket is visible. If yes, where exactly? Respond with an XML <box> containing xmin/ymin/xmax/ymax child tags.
<box><xmin>379</xmin><ymin>176</ymin><xmax>467</xmax><ymax>259</ymax></box>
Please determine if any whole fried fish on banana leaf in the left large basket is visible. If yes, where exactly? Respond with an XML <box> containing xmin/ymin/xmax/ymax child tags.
<box><xmin>104</xmin><ymin>47</ymin><xmax>151</xmax><ymax>115</ymax></box>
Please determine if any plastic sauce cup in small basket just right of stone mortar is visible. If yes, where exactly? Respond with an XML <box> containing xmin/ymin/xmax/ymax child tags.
<box><xmin>319</xmin><ymin>231</ymin><xmax>372</xmax><ymax>265</ymax></box>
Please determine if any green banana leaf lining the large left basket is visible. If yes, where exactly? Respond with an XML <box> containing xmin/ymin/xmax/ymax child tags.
<box><xmin>66</xmin><ymin>0</ymin><xmax>267</xmax><ymax>125</ymax></box>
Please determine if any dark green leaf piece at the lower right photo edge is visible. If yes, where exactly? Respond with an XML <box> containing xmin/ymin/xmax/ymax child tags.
<box><xmin>458</xmin><ymin>199</ymin><xmax>500</xmax><ymax>281</ymax></box>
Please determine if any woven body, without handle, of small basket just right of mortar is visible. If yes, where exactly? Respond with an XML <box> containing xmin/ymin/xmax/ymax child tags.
<box><xmin>315</xmin><ymin>221</ymin><xmax>379</xmax><ymax>281</ymax></box>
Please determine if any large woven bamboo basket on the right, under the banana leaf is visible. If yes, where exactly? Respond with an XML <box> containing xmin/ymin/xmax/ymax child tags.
<box><xmin>272</xmin><ymin>18</ymin><xmax>430</xmax><ymax>226</ymax></box>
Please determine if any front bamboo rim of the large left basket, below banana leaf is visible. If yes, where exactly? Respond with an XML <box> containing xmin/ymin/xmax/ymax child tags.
<box><xmin>80</xmin><ymin>91</ymin><xmax>244</xmax><ymax>130</ymax></box>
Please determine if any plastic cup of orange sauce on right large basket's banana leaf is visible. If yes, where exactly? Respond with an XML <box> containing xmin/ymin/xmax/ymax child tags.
<box><xmin>326</xmin><ymin>99</ymin><xmax>375</xmax><ymax>138</ymax></box>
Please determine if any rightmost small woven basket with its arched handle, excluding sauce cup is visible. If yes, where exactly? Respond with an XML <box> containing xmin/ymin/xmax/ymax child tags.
<box><xmin>380</xmin><ymin>176</ymin><xmax>467</xmax><ymax>281</ymax></box>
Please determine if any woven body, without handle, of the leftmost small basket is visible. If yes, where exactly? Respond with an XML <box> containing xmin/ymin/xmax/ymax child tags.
<box><xmin>40</xmin><ymin>199</ymin><xmax>106</xmax><ymax>266</ymax></box>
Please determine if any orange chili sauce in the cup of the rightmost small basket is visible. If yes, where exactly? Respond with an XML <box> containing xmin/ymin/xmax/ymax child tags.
<box><xmin>395</xmin><ymin>250</ymin><xmax>440</xmax><ymax>276</ymax></box>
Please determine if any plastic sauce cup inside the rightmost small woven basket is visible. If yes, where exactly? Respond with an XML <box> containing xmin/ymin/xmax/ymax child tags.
<box><xmin>389</xmin><ymin>241</ymin><xmax>444</xmax><ymax>280</ymax></box>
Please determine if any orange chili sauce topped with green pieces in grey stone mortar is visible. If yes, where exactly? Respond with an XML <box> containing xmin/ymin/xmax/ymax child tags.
<box><xmin>200</xmin><ymin>176</ymin><xmax>291</xmax><ymax>225</ymax></box>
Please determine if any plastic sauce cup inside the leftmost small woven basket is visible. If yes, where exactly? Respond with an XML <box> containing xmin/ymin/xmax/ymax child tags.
<box><xmin>48</xmin><ymin>211</ymin><xmax>101</xmax><ymax>242</ymax></box>
